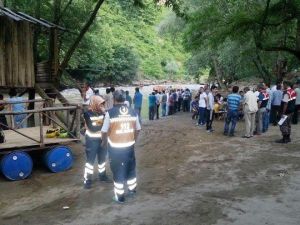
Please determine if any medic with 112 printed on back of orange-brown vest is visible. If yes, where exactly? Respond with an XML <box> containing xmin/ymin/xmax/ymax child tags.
<box><xmin>101</xmin><ymin>90</ymin><xmax>141</xmax><ymax>203</ymax></box>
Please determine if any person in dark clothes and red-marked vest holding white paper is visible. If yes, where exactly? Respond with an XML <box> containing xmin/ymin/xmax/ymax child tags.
<box><xmin>276</xmin><ymin>81</ymin><xmax>297</xmax><ymax>144</ymax></box>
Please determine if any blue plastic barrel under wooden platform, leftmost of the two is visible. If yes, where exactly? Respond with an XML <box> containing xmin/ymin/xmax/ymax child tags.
<box><xmin>0</xmin><ymin>151</ymin><xmax>33</xmax><ymax>180</ymax></box>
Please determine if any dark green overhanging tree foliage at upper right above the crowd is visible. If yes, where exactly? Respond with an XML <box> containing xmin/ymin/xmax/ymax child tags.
<box><xmin>161</xmin><ymin>0</ymin><xmax>300</xmax><ymax>82</ymax></box>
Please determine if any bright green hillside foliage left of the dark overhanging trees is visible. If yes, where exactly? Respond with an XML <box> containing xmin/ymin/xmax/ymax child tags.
<box><xmin>5</xmin><ymin>0</ymin><xmax>188</xmax><ymax>83</ymax></box>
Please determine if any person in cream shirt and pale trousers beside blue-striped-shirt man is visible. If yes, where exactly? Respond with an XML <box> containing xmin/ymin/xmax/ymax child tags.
<box><xmin>243</xmin><ymin>87</ymin><xmax>258</xmax><ymax>138</ymax></box>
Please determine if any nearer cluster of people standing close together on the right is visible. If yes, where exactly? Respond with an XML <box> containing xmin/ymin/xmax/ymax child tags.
<box><xmin>191</xmin><ymin>81</ymin><xmax>300</xmax><ymax>143</ymax></box>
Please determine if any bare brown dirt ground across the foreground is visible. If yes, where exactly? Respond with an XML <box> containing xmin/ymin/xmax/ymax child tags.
<box><xmin>0</xmin><ymin>113</ymin><xmax>300</xmax><ymax>225</ymax></box>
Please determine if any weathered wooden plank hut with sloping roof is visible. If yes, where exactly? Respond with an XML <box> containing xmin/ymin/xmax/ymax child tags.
<box><xmin>0</xmin><ymin>6</ymin><xmax>65</xmax><ymax>88</ymax></box>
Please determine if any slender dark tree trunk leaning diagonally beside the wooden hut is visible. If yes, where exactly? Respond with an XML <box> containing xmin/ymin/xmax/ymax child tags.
<box><xmin>57</xmin><ymin>0</ymin><xmax>104</xmax><ymax>80</ymax></box>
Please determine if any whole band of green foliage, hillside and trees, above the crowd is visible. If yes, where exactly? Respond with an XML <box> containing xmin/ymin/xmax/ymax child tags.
<box><xmin>2</xmin><ymin>0</ymin><xmax>300</xmax><ymax>85</ymax></box>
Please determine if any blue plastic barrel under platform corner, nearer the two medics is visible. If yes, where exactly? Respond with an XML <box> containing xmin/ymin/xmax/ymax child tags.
<box><xmin>45</xmin><ymin>145</ymin><xmax>73</xmax><ymax>173</ymax></box>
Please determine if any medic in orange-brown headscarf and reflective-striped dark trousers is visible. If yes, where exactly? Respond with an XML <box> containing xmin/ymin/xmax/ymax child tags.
<box><xmin>83</xmin><ymin>95</ymin><xmax>110</xmax><ymax>189</ymax></box>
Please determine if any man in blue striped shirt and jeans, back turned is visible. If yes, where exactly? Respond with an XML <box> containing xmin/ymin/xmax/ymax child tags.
<box><xmin>224</xmin><ymin>86</ymin><xmax>242</xmax><ymax>137</ymax></box>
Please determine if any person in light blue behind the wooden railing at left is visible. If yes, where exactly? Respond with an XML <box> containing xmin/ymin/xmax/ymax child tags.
<box><xmin>8</xmin><ymin>88</ymin><xmax>27</xmax><ymax>128</ymax></box>
